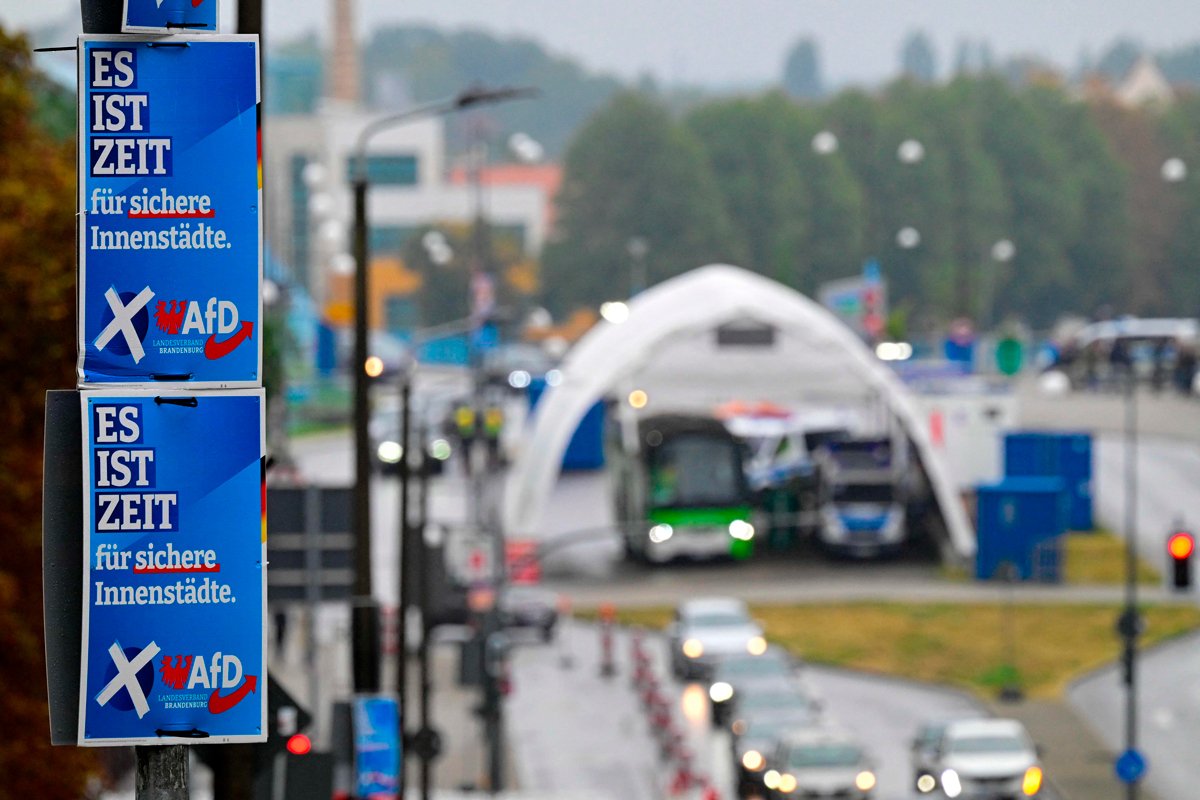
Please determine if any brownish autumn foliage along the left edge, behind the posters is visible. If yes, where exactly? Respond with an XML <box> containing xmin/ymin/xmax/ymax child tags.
<box><xmin>0</xmin><ymin>30</ymin><xmax>91</xmax><ymax>798</ymax></box>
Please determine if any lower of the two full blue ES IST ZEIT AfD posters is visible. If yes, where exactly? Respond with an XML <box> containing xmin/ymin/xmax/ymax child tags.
<box><xmin>79</xmin><ymin>389</ymin><xmax>266</xmax><ymax>745</ymax></box>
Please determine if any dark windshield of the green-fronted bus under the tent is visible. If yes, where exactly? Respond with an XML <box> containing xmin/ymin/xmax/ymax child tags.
<box><xmin>648</xmin><ymin>435</ymin><xmax>746</xmax><ymax>507</ymax></box>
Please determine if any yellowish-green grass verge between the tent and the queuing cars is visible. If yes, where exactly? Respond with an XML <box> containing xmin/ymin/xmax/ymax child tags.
<box><xmin>604</xmin><ymin>602</ymin><xmax>1200</xmax><ymax>698</ymax></box>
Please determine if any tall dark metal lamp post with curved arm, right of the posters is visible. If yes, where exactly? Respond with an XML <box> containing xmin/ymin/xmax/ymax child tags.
<box><xmin>352</xmin><ymin>86</ymin><xmax>529</xmax><ymax>692</ymax></box>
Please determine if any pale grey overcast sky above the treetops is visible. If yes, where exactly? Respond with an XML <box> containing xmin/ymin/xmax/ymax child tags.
<box><xmin>9</xmin><ymin>0</ymin><xmax>1200</xmax><ymax>85</ymax></box>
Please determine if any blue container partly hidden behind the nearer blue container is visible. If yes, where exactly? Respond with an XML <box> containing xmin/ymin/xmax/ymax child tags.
<box><xmin>1004</xmin><ymin>431</ymin><xmax>1096</xmax><ymax>530</ymax></box>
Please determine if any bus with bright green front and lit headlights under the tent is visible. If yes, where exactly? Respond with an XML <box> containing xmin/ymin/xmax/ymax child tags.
<box><xmin>610</xmin><ymin>414</ymin><xmax>755</xmax><ymax>564</ymax></box>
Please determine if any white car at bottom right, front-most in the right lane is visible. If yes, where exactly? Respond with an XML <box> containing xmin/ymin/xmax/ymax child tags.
<box><xmin>936</xmin><ymin>720</ymin><xmax>1043</xmax><ymax>800</ymax></box>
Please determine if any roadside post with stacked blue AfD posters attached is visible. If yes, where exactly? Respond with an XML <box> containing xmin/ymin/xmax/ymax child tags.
<box><xmin>44</xmin><ymin>0</ymin><xmax>268</xmax><ymax>800</ymax></box>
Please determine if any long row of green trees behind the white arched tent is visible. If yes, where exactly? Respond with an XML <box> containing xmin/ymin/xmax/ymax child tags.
<box><xmin>546</xmin><ymin>65</ymin><xmax>1200</xmax><ymax>330</ymax></box>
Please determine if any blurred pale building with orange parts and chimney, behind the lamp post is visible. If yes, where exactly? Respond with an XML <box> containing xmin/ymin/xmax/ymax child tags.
<box><xmin>263</xmin><ymin>0</ymin><xmax>560</xmax><ymax>332</ymax></box>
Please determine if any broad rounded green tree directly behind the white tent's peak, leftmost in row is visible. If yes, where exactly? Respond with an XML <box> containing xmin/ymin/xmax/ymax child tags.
<box><xmin>542</xmin><ymin>94</ymin><xmax>744</xmax><ymax>311</ymax></box>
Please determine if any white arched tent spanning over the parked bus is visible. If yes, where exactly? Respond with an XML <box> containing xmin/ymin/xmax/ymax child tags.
<box><xmin>504</xmin><ymin>264</ymin><xmax>976</xmax><ymax>559</ymax></box>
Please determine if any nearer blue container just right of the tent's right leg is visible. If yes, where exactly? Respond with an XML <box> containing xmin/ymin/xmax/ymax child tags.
<box><xmin>976</xmin><ymin>477</ymin><xmax>1069</xmax><ymax>583</ymax></box>
